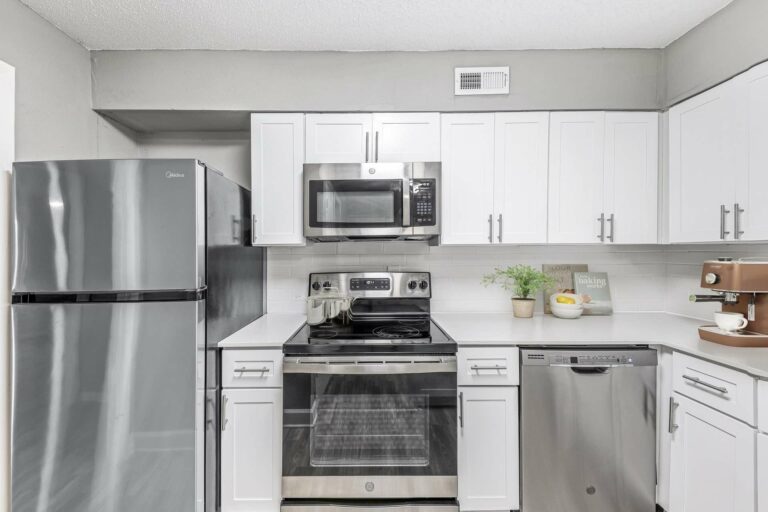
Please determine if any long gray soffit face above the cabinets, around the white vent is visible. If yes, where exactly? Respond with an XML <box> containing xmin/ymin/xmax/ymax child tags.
<box><xmin>91</xmin><ymin>50</ymin><xmax>664</xmax><ymax>111</ymax></box>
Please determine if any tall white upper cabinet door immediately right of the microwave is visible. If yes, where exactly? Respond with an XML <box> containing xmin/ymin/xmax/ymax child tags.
<box><xmin>441</xmin><ymin>114</ymin><xmax>494</xmax><ymax>245</ymax></box>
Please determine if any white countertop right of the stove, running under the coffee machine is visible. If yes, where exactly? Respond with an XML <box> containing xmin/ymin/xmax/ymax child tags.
<box><xmin>432</xmin><ymin>313</ymin><xmax>768</xmax><ymax>379</ymax></box>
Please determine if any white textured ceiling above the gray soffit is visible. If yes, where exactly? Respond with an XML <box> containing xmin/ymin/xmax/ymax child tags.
<box><xmin>22</xmin><ymin>0</ymin><xmax>732</xmax><ymax>51</ymax></box>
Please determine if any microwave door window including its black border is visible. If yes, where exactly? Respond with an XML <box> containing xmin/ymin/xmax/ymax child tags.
<box><xmin>307</xmin><ymin>180</ymin><xmax>403</xmax><ymax>228</ymax></box>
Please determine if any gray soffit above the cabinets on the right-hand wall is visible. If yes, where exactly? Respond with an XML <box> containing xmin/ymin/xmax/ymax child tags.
<box><xmin>664</xmin><ymin>0</ymin><xmax>768</xmax><ymax>106</ymax></box>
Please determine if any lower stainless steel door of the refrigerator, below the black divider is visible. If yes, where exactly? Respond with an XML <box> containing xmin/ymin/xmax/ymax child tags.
<box><xmin>11</xmin><ymin>301</ymin><xmax>205</xmax><ymax>512</ymax></box>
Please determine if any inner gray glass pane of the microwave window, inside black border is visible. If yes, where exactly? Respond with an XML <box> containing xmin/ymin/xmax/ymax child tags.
<box><xmin>317</xmin><ymin>190</ymin><xmax>395</xmax><ymax>225</ymax></box>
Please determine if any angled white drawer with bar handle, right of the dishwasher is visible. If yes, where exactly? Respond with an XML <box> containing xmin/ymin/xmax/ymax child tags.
<box><xmin>672</xmin><ymin>352</ymin><xmax>756</xmax><ymax>425</ymax></box>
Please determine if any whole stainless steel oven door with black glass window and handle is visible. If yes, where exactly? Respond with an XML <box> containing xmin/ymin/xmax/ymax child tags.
<box><xmin>283</xmin><ymin>355</ymin><xmax>457</xmax><ymax>499</ymax></box>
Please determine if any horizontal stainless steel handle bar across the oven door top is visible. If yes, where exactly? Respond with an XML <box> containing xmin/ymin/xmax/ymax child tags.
<box><xmin>283</xmin><ymin>358</ymin><xmax>456</xmax><ymax>375</ymax></box>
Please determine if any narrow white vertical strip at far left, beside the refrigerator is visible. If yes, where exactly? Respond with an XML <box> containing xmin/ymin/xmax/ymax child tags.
<box><xmin>0</xmin><ymin>61</ymin><xmax>16</xmax><ymax>510</ymax></box>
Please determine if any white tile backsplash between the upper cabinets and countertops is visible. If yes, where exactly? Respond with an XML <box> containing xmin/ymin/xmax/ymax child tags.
<box><xmin>267</xmin><ymin>242</ymin><xmax>768</xmax><ymax>318</ymax></box>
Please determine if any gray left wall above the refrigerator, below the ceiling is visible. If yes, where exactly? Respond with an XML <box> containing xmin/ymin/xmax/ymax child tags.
<box><xmin>0</xmin><ymin>0</ymin><xmax>97</xmax><ymax>160</ymax></box>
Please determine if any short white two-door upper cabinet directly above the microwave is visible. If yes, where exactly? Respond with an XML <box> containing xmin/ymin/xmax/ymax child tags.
<box><xmin>306</xmin><ymin>113</ymin><xmax>440</xmax><ymax>163</ymax></box>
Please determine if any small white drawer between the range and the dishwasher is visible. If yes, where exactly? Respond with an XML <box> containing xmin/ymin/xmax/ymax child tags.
<box><xmin>457</xmin><ymin>347</ymin><xmax>520</xmax><ymax>386</ymax></box>
